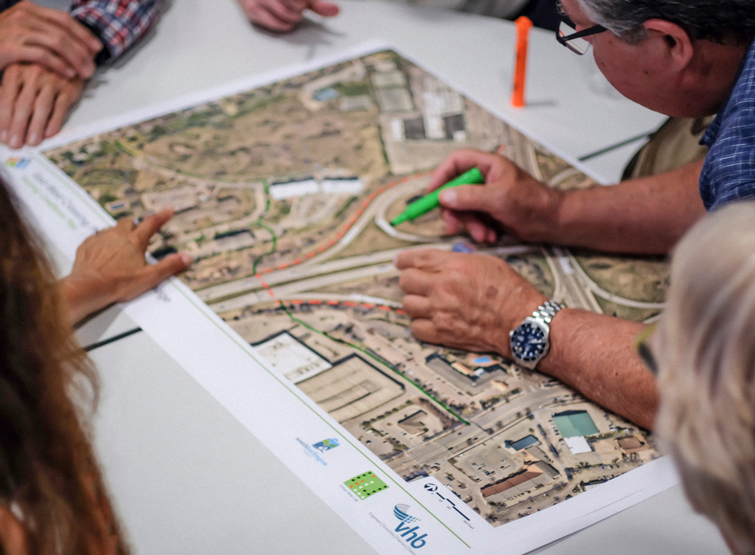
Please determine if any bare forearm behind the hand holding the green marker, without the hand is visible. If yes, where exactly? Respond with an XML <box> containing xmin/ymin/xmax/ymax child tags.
<box><xmin>542</xmin><ymin>162</ymin><xmax>705</xmax><ymax>254</ymax></box>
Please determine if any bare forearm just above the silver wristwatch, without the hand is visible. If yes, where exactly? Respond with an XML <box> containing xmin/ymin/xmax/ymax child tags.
<box><xmin>539</xmin><ymin>309</ymin><xmax>658</xmax><ymax>429</ymax></box>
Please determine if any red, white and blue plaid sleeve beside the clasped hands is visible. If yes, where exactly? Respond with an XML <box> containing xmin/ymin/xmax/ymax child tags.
<box><xmin>71</xmin><ymin>0</ymin><xmax>162</xmax><ymax>63</ymax></box>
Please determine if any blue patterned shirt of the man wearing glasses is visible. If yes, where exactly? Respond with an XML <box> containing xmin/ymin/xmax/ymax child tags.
<box><xmin>700</xmin><ymin>37</ymin><xmax>755</xmax><ymax>210</ymax></box>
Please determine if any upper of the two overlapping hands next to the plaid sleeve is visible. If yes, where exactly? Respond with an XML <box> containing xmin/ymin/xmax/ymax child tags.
<box><xmin>0</xmin><ymin>0</ymin><xmax>102</xmax><ymax>79</ymax></box>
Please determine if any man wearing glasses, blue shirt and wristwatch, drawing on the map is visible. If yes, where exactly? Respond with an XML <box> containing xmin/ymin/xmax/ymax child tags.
<box><xmin>395</xmin><ymin>0</ymin><xmax>755</xmax><ymax>428</ymax></box>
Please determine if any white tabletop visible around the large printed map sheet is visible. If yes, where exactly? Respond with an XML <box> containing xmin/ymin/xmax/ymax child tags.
<box><xmin>37</xmin><ymin>0</ymin><xmax>727</xmax><ymax>555</ymax></box>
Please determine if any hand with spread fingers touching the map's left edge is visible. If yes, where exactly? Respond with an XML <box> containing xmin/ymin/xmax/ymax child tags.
<box><xmin>61</xmin><ymin>209</ymin><xmax>192</xmax><ymax>323</ymax></box>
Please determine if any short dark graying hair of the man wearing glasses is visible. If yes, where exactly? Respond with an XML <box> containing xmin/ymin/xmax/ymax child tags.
<box><xmin>578</xmin><ymin>0</ymin><xmax>755</xmax><ymax>44</ymax></box>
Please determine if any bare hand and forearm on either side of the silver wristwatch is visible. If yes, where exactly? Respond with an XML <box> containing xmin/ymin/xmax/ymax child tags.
<box><xmin>394</xmin><ymin>249</ymin><xmax>658</xmax><ymax>429</ymax></box>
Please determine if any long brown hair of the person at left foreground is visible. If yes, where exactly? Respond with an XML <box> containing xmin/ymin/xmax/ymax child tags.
<box><xmin>0</xmin><ymin>180</ymin><xmax>127</xmax><ymax>555</ymax></box>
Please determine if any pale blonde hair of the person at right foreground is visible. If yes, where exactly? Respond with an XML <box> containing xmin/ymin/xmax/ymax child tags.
<box><xmin>654</xmin><ymin>202</ymin><xmax>755</xmax><ymax>555</ymax></box>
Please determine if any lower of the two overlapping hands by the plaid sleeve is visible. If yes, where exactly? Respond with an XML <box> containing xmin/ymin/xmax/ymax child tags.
<box><xmin>0</xmin><ymin>64</ymin><xmax>84</xmax><ymax>148</ymax></box>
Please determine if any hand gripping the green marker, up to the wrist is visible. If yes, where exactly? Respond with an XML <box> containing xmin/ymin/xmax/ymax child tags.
<box><xmin>427</xmin><ymin>150</ymin><xmax>563</xmax><ymax>243</ymax></box>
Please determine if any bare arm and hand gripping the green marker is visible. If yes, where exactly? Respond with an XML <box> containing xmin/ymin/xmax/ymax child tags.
<box><xmin>428</xmin><ymin>150</ymin><xmax>705</xmax><ymax>254</ymax></box>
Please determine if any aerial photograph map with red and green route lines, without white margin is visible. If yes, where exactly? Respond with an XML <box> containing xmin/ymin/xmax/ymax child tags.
<box><xmin>45</xmin><ymin>51</ymin><xmax>668</xmax><ymax>526</ymax></box>
